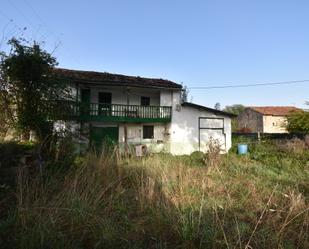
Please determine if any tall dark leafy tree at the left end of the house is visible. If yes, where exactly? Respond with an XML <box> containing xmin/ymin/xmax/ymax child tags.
<box><xmin>0</xmin><ymin>38</ymin><xmax>66</xmax><ymax>140</ymax></box>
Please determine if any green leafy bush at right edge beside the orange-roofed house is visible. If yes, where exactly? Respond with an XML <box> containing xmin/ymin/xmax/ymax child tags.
<box><xmin>286</xmin><ymin>108</ymin><xmax>309</xmax><ymax>134</ymax></box>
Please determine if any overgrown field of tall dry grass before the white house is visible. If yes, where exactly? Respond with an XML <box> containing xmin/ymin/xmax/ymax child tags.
<box><xmin>0</xmin><ymin>140</ymin><xmax>309</xmax><ymax>249</ymax></box>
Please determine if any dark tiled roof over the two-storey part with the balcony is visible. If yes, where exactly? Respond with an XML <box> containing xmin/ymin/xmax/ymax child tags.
<box><xmin>54</xmin><ymin>68</ymin><xmax>182</xmax><ymax>90</ymax></box>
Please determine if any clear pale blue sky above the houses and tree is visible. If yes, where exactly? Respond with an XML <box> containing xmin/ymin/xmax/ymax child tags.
<box><xmin>0</xmin><ymin>0</ymin><xmax>309</xmax><ymax>108</ymax></box>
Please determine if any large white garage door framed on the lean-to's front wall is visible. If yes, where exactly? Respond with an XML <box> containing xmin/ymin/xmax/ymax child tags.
<box><xmin>199</xmin><ymin>117</ymin><xmax>226</xmax><ymax>152</ymax></box>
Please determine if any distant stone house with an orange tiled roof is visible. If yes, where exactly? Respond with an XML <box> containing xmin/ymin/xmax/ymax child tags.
<box><xmin>237</xmin><ymin>106</ymin><xmax>300</xmax><ymax>133</ymax></box>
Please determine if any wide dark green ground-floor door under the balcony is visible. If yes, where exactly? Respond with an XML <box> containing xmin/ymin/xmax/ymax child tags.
<box><xmin>90</xmin><ymin>127</ymin><xmax>118</xmax><ymax>150</ymax></box>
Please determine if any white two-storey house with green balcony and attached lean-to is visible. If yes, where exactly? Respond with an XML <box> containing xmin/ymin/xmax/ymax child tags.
<box><xmin>53</xmin><ymin>68</ymin><xmax>234</xmax><ymax>155</ymax></box>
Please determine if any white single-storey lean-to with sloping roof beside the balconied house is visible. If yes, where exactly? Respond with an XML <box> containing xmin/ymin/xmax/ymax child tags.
<box><xmin>170</xmin><ymin>102</ymin><xmax>235</xmax><ymax>155</ymax></box>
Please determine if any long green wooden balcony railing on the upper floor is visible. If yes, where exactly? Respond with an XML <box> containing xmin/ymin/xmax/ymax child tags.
<box><xmin>50</xmin><ymin>101</ymin><xmax>172</xmax><ymax>123</ymax></box>
